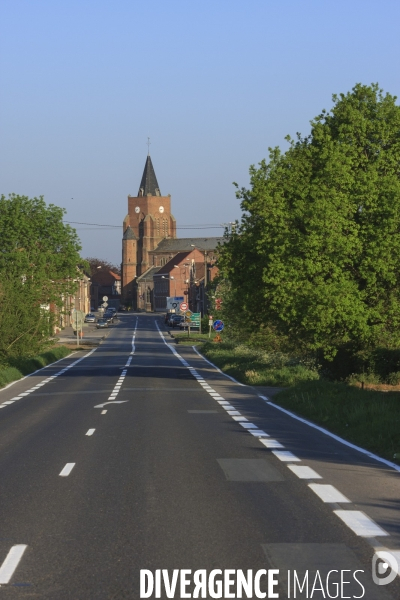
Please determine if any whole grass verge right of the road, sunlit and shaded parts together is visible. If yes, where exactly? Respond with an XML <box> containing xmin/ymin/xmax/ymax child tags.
<box><xmin>201</xmin><ymin>342</ymin><xmax>400</xmax><ymax>464</ymax></box>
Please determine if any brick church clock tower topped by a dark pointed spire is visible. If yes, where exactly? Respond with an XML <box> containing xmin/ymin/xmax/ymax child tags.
<box><xmin>122</xmin><ymin>154</ymin><xmax>176</xmax><ymax>302</ymax></box>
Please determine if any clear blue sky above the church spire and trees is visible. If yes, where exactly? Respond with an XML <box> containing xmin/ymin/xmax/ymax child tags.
<box><xmin>0</xmin><ymin>0</ymin><xmax>400</xmax><ymax>263</ymax></box>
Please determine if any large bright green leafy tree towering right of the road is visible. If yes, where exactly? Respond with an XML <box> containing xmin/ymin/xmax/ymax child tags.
<box><xmin>220</xmin><ymin>84</ymin><xmax>400</xmax><ymax>358</ymax></box>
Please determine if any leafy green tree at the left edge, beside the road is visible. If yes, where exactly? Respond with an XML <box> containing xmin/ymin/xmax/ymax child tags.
<box><xmin>0</xmin><ymin>194</ymin><xmax>82</xmax><ymax>360</ymax></box>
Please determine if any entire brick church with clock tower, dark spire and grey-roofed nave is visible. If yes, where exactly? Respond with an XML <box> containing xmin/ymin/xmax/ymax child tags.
<box><xmin>121</xmin><ymin>154</ymin><xmax>224</xmax><ymax>313</ymax></box>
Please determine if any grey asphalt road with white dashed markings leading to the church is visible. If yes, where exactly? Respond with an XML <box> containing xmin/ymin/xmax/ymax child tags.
<box><xmin>0</xmin><ymin>315</ymin><xmax>400</xmax><ymax>600</ymax></box>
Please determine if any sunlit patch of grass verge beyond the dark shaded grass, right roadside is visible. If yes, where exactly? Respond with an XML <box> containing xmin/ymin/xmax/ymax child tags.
<box><xmin>201</xmin><ymin>340</ymin><xmax>319</xmax><ymax>387</ymax></box>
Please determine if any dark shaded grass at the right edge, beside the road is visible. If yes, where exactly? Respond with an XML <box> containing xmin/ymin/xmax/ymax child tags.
<box><xmin>274</xmin><ymin>380</ymin><xmax>400</xmax><ymax>464</ymax></box>
